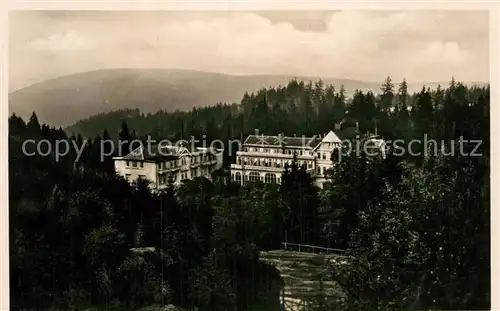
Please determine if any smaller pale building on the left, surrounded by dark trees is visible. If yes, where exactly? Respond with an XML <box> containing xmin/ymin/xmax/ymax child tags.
<box><xmin>113</xmin><ymin>145</ymin><xmax>223</xmax><ymax>190</ymax></box>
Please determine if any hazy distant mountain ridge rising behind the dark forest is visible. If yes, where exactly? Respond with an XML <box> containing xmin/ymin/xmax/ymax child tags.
<box><xmin>9</xmin><ymin>68</ymin><xmax>484</xmax><ymax>126</ymax></box>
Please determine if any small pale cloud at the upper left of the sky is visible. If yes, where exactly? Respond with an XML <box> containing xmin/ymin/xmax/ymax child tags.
<box><xmin>29</xmin><ymin>32</ymin><xmax>92</xmax><ymax>52</ymax></box>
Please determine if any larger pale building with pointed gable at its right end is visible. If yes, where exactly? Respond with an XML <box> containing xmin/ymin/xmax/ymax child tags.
<box><xmin>231</xmin><ymin>130</ymin><xmax>342</xmax><ymax>188</ymax></box>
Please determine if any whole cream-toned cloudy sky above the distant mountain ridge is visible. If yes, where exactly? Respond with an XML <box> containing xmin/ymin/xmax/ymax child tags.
<box><xmin>9</xmin><ymin>11</ymin><xmax>489</xmax><ymax>91</ymax></box>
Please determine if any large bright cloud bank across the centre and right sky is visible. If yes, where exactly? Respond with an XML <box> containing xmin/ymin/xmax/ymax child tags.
<box><xmin>151</xmin><ymin>11</ymin><xmax>480</xmax><ymax>79</ymax></box>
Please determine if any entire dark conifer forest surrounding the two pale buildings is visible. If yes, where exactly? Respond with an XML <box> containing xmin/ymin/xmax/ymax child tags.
<box><xmin>9</xmin><ymin>79</ymin><xmax>490</xmax><ymax>310</ymax></box>
